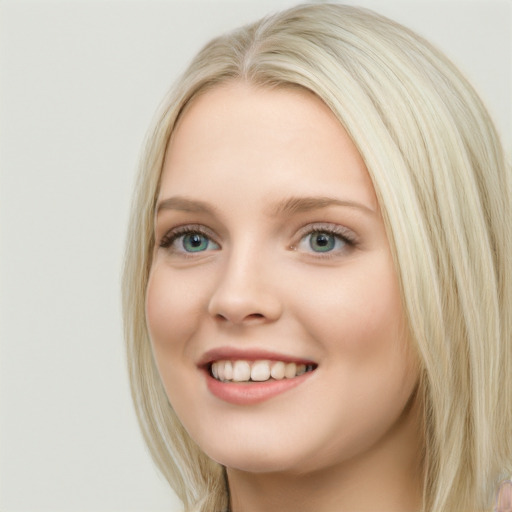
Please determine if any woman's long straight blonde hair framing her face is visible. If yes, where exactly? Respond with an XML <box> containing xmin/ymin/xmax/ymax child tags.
<box><xmin>123</xmin><ymin>4</ymin><xmax>512</xmax><ymax>512</ymax></box>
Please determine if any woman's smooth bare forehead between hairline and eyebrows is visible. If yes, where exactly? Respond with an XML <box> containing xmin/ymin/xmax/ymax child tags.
<box><xmin>161</xmin><ymin>82</ymin><xmax>376</xmax><ymax>212</ymax></box>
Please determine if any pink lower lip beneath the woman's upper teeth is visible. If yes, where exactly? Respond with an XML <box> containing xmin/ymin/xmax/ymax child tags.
<box><xmin>206</xmin><ymin>371</ymin><xmax>314</xmax><ymax>405</ymax></box>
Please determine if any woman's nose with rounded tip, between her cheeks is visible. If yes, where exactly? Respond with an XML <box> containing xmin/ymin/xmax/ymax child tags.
<box><xmin>208</xmin><ymin>248</ymin><xmax>282</xmax><ymax>325</ymax></box>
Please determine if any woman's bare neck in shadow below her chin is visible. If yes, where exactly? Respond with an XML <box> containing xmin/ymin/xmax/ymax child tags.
<box><xmin>227</xmin><ymin>392</ymin><xmax>423</xmax><ymax>512</ymax></box>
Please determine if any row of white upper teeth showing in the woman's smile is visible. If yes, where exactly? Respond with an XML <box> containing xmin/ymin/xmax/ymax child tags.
<box><xmin>208</xmin><ymin>359</ymin><xmax>317</xmax><ymax>382</ymax></box>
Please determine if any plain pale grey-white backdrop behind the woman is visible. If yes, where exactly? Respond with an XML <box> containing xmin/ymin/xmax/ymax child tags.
<box><xmin>0</xmin><ymin>0</ymin><xmax>512</xmax><ymax>512</ymax></box>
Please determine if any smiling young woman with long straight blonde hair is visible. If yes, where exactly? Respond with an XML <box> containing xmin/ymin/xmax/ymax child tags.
<box><xmin>124</xmin><ymin>4</ymin><xmax>512</xmax><ymax>512</ymax></box>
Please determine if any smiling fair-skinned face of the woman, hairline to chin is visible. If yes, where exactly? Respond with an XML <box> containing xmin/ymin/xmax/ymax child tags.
<box><xmin>146</xmin><ymin>83</ymin><xmax>417</xmax><ymax>472</ymax></box>
